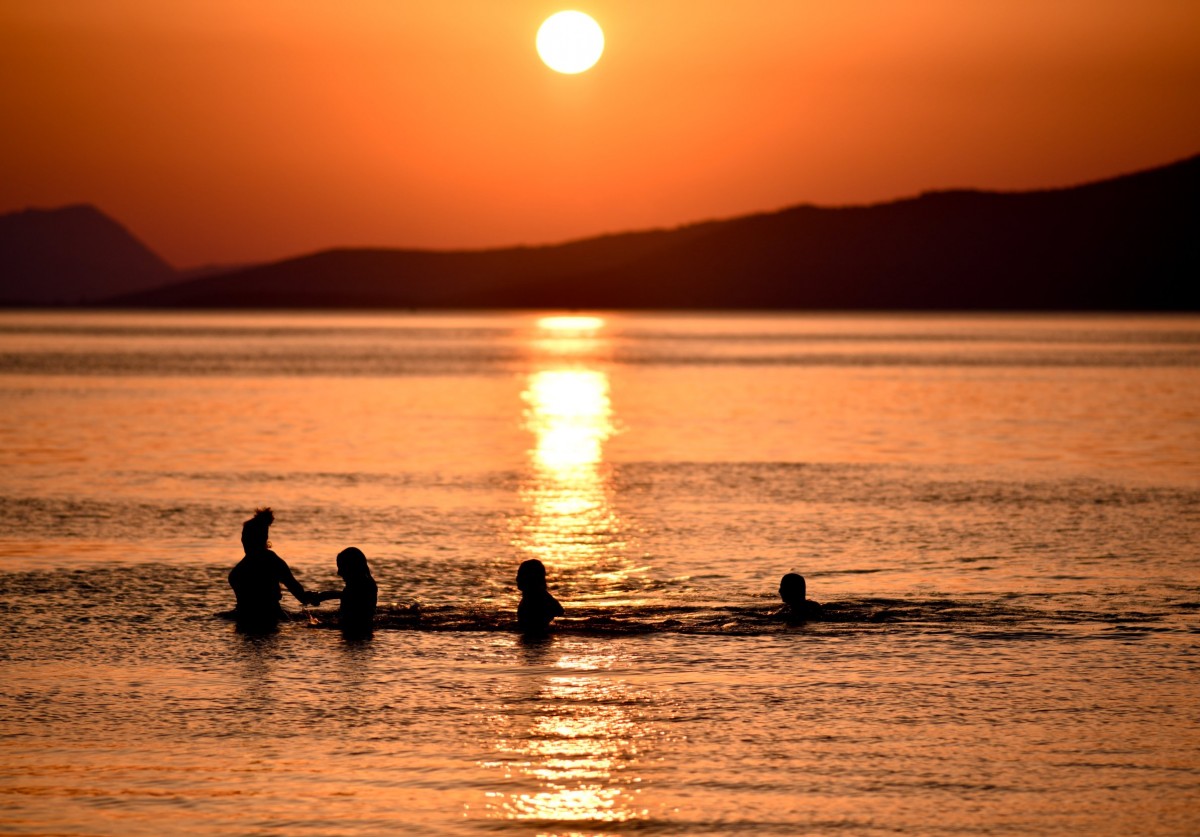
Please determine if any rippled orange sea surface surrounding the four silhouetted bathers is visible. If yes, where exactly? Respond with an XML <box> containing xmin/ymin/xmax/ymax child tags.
<box><xmin>0</xmin><ymin>312</ymin><xmax>1200</xmax><ymax>837</ymax></box>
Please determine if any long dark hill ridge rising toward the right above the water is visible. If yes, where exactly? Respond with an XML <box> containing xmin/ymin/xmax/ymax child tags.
<box><xmin>11</xmin><ymin>156</ymin><xmax>1200</xmax><ymax>311</ymax></box>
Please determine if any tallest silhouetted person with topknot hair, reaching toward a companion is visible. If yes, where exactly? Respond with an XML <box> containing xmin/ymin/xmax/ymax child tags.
<box><xmin>229</xmin><ymin>508</ymin><xmax>317</xmax><ymax>626</ymax></box>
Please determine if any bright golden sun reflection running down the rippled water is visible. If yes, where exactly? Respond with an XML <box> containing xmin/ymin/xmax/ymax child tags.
<box><xmin>485</xmin><ymin>317</ymin><xmax>647</xmax><ymax>833</ymax></box>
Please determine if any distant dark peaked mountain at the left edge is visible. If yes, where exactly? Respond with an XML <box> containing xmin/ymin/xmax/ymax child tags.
<box><xmin>0</xmin><ymin>205</ymin><xmax>179</xmax><ymax>305</ymax></box>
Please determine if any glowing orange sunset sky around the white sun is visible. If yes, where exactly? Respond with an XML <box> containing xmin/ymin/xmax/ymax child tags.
<box><xmin>0</xmin><ymin>0</ymin><xmax>1200</xmax><ymax>266</ymax></box>
